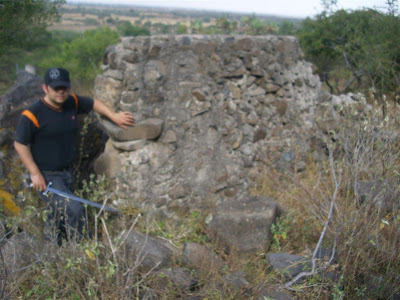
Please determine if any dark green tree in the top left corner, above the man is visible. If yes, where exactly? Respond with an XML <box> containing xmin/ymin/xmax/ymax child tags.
<box><xmin>0</xmin><ymin>0</ymin><xmax>65</xmax><ymax>57</ymax></box>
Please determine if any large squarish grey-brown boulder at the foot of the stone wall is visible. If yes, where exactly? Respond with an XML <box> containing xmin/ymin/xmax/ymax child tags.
<box><xmin>208</xmin><ymin>197</ymin><xmax>280</xmax><ymax>253</ymax></box>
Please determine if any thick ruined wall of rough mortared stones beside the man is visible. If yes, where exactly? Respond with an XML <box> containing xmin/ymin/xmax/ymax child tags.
<box><xmin>95</xmin><ymin>35</ymin><xmax>321</xmax><ymax>217</ymax></box>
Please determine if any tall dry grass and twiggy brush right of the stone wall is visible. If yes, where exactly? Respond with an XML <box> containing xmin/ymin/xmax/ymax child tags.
<box><xmin>253</xmin><ymin>98</ymin><xmax>400</xmax><ymax>299</ymax></box>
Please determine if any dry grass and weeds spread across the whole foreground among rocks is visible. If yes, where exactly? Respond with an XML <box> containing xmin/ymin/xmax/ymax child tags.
<box><xmin>6</xmin><ymin>96</ymin><xmax>400</xmax><ymax>299</ymax></box>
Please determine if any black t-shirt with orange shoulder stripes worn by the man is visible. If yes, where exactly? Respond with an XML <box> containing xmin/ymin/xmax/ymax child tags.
<box><xmin>15</xmin><ymin>95</ymin><xmax>94</xmax><ymax>171</ymax></box>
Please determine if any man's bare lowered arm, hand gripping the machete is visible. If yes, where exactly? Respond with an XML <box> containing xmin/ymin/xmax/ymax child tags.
<box><xmin>14</xmin><ymin>141</ymin><xmax>46</xmax><ymax>191</ymax></box>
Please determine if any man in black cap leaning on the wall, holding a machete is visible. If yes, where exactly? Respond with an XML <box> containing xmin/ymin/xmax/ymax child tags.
<box><xmin>14</xmin><ymin>68</ymin><xmax>135</xmax><ymax>244</ymax></box>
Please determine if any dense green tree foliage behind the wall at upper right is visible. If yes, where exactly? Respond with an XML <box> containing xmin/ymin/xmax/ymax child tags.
<box><xmin>298</xmin><ymin>9</ymin><xmax>400</xmax><ymax>94</ymax></box>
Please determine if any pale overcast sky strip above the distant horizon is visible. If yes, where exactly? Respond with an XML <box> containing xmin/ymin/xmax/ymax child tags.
<box><xmin>67</xmin><ymin>0</ymin><xmax>386</xmax><ymax>17</ymax></box>
